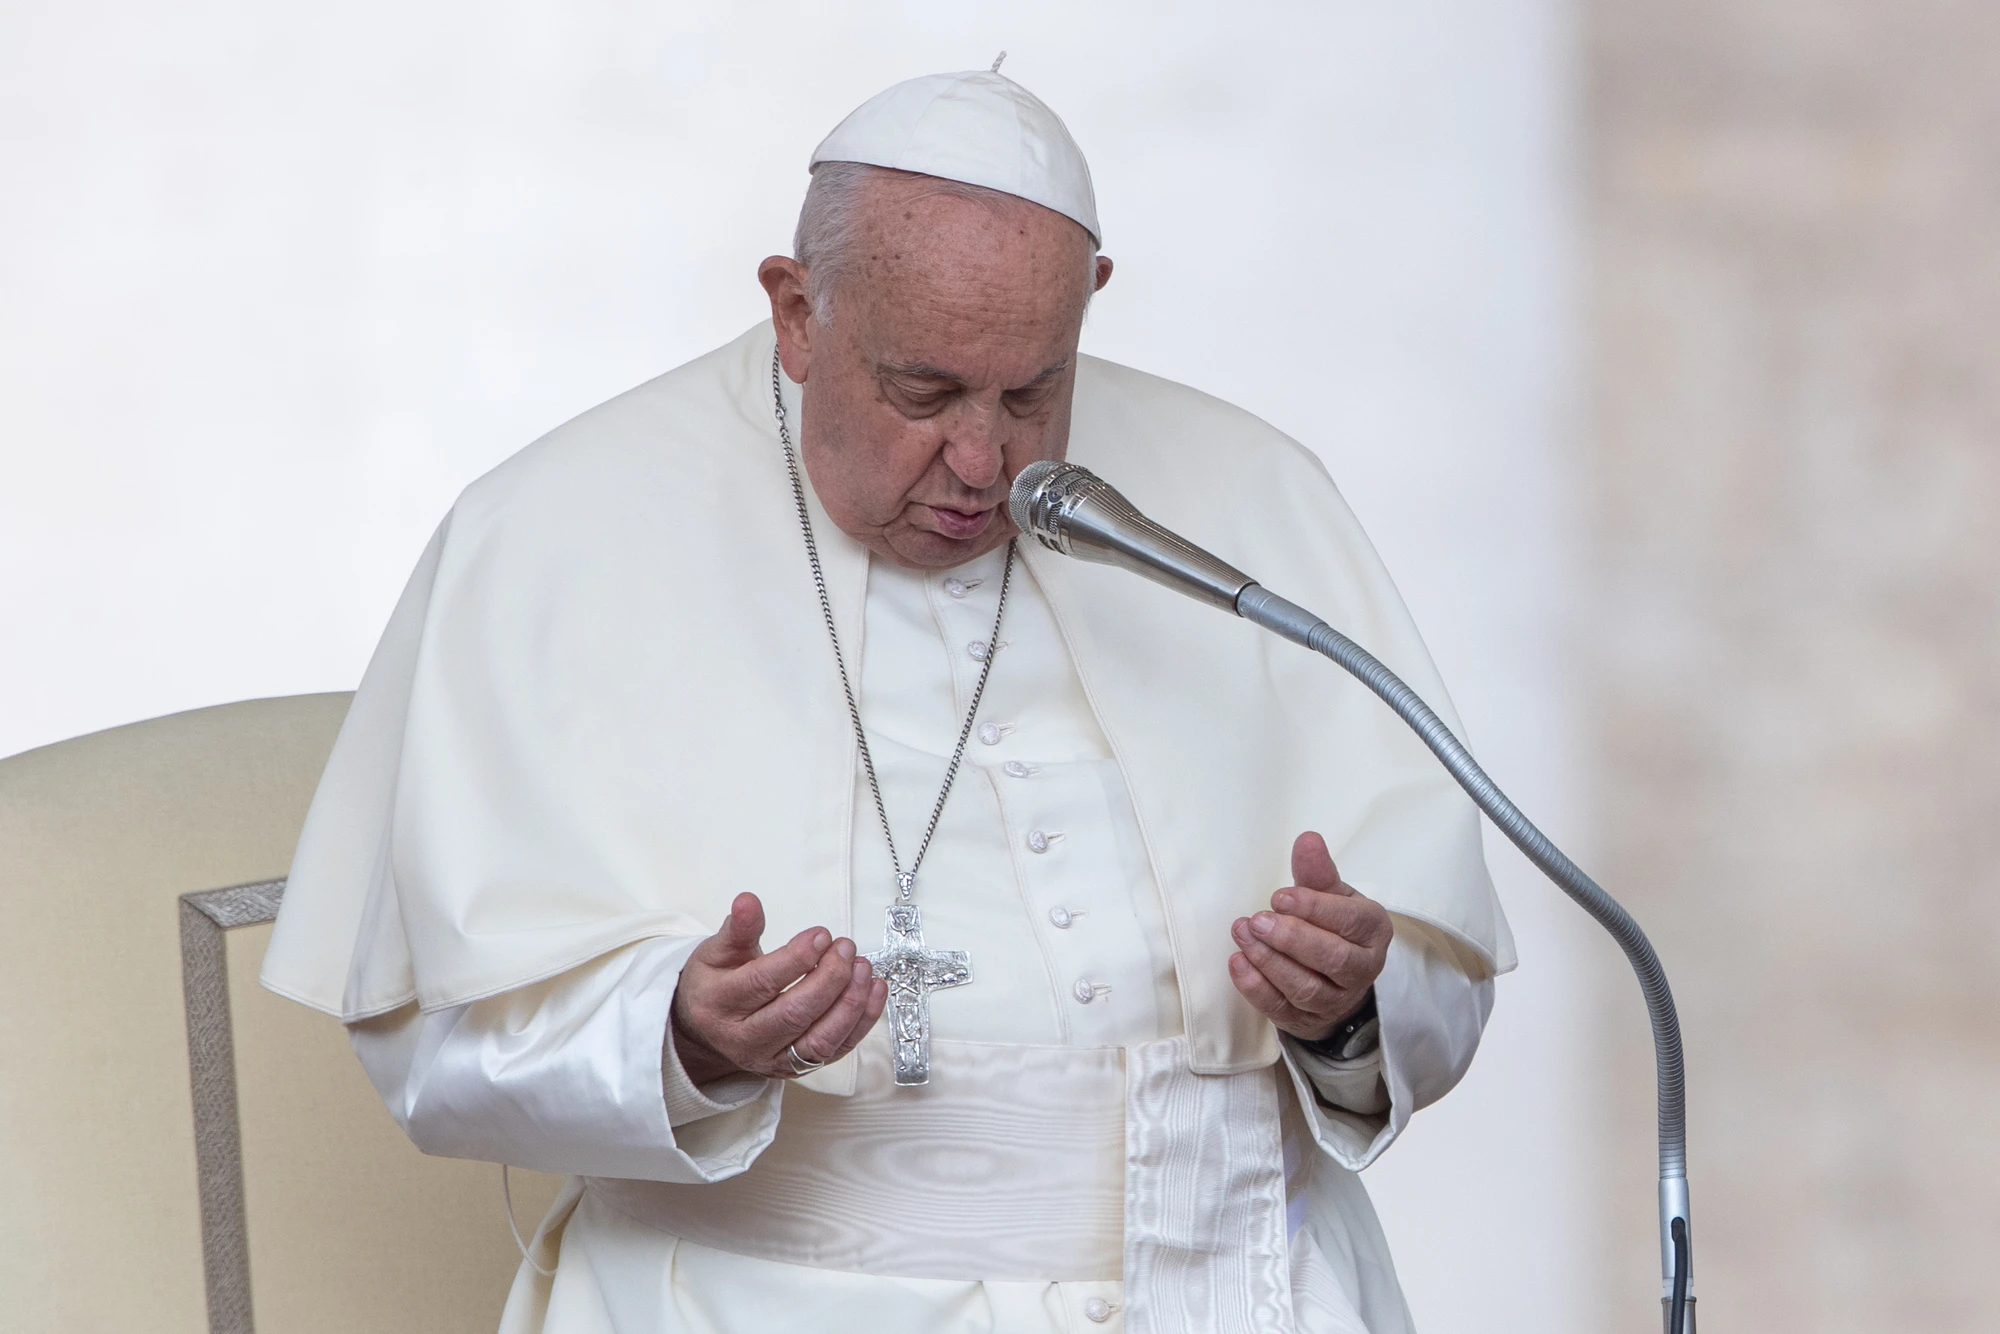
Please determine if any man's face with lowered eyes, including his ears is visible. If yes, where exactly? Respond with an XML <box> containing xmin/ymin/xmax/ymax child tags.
<box><xmin>758</xmin><ymin>176</ymin><xmax>1110</xmax><ymax>570</ymax></box>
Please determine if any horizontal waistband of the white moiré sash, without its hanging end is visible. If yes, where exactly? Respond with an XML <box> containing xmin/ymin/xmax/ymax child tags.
<box><xmin>590</xmin><ymin>1028</ymin><xmax>1128</xmax><ymax>1282</ymax></box>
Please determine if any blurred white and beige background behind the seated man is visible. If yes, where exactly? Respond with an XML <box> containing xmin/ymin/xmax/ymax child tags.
<box><xmin>0</xmin><ymin>0</ymin><xmax>2000</xmax><ymax>1334</ymax></box>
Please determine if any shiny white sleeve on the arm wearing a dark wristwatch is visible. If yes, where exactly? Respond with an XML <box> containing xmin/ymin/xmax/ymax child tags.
<box><xmin>1280</xmin><ymin>916</ymin><xmax>1494</xmax><ymax>1172</ymax></box>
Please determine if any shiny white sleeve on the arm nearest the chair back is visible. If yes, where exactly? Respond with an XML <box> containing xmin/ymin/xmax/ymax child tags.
<box><xmin>348</xmin><ymin>936</ymin><xmax>782</xmax><ymax>1182</ymax></box>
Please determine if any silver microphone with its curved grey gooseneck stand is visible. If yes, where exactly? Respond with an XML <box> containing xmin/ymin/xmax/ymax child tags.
<box><xmin>1008</xmin><ymin>460</ymin><xmax>1694</xmax><ymax>1334</ymax></box>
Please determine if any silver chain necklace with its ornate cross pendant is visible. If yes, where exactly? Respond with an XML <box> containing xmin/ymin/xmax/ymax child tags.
<box><xmin>770</xmin><ymin>348</ymin><xmax>1014</xmax><ymax>1086</ymax></box>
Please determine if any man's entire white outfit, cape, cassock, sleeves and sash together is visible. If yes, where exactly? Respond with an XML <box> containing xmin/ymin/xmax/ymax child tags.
<box><xmin>264</xmin><ymin>326</ymin><xmax>1512</xmax><ymax>1334</ymax></box>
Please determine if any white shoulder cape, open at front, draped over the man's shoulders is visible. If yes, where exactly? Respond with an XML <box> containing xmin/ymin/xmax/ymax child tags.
<box><xmin>262</xmin><ymin>324</ymin><xmax>1514</xmax><ymax>1082</ymax></box>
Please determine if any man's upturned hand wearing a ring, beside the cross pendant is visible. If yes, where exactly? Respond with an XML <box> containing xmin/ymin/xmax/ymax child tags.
<box><xmin>674</xmin><ymin>894</ymin><xmax>888</xmax><ymax>1084</ymax></box>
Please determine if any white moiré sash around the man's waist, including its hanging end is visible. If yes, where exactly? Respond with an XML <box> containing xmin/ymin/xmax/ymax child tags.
<box><xmin>588</xmin><ymin>1038</ymin><xmax>1294</xmax><ymax>1334</ymax></box>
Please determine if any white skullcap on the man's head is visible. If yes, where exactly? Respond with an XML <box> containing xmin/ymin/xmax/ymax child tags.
<box><xmin>808</xmin><ymin>68</ymin><xmax>1104</xmax><ymax>246</ymax></box>
